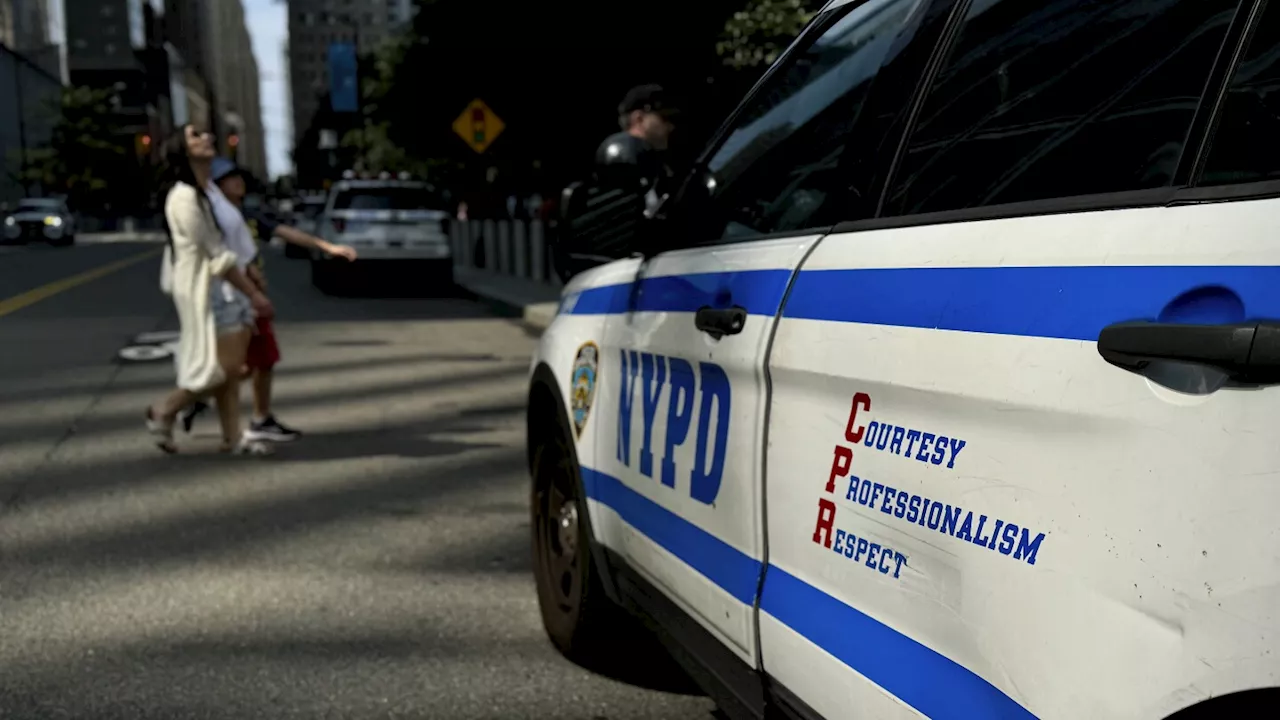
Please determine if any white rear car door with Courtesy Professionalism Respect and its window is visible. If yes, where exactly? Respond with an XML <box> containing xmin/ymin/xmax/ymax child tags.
<box><xmin>760</xmin><ymin>0</ymin><xmax>1280</xmax><ymax>720</ymax></box>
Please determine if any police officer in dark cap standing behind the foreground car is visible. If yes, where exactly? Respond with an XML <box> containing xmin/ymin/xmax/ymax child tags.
<box><xmin>595</xmin><ymin>85</ymin><xmax>678</xmax><ymax>214</ymax></box>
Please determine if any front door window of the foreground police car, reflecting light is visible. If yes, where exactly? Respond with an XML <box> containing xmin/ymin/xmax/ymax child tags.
<box><xmin>707</xmin><ymin>0</ymin><xmax>925</xmax><ymax>240</ymax></box>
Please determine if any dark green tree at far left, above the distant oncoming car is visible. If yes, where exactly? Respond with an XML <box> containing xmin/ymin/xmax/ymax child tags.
<box><xmin>22</xmin><ymin>87</ymin><xmax>127</xmax><ymax>208</ymax></box>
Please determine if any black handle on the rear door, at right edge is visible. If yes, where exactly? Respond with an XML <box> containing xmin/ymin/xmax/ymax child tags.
<box><xmin>1098</xmin><ymin>320</ymin><xmax>1280</xmax><ymax>384</ymax></box>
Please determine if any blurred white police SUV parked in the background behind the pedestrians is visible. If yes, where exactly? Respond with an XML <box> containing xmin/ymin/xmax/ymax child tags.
<box><xmin>311</xmin><ymin>172</ymin><xmax>453</xmax><ymax>290</ymax></box>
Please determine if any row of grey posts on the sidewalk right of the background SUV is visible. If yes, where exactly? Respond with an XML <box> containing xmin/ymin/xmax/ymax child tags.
<box><xmin>449</xmin><ymin>220</ymin><xmax>563</xmax><ymax>288</ymax></box>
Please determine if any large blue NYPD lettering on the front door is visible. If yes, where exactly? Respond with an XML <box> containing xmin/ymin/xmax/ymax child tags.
<box><xmin>617</xmin><ymin>350</ymin><xmax>732</xmax><ymax>505</ymax></box>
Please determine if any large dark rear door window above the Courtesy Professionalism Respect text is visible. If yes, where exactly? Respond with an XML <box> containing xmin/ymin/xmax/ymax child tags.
<box><xmin>884</xmin><ymin>0</ymin><xmax>1239</xmax><ymax>215</ymax></box>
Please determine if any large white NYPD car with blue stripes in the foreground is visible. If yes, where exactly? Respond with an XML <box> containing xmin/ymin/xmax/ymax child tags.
<box><xmin>529</xmin><ymin>0</ymin><xmax>1280</xmax><ymax>720</ymax></box>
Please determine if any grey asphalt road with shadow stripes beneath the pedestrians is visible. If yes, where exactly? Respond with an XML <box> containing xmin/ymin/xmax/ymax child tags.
<box><xmin>0</xmin><ymin>245</ymin><xmax>713</xmax><ymax>720</ymax></box>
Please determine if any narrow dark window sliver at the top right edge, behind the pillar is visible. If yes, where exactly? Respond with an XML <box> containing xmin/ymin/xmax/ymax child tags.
<box><xmin>1199</xmin><ymin>3</ymin><xmax>1280</xmax><ymax>184</ymax></box>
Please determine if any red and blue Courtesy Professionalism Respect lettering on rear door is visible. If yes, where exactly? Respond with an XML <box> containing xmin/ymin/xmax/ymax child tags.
<box><xmin>813</xmin><ymin>392</ymin><xmax>1044</xmax><ymax>568</ymax></box>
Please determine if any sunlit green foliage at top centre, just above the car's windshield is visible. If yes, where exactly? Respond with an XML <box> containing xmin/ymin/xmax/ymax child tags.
<box><xmin>716</xmin><ymin>0</ymin><xmax>817</xmax><ymax>70</ymax></box>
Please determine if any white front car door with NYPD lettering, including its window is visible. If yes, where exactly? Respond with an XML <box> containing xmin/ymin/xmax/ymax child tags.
<box><xmin>596</xmin><ymin>0</ymin><xmax>942</xmax><ymax>666</ymax></box>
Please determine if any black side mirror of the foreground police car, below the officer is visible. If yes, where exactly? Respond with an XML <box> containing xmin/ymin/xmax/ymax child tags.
<box><xmin>550</xmin><ymin>182</ymin><xmax>648</xmax><ymax>281</ymax></box>
